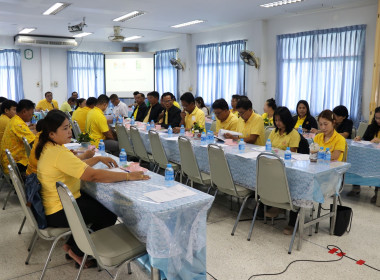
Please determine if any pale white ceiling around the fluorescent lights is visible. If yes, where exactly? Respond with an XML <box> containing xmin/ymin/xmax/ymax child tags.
<box><xmin>0</xmin><ymin>0</ymin><xmax>377</xmax><ymax>43</ymax></box>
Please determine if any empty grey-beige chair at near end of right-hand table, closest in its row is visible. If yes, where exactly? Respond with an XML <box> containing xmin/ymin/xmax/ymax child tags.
<box><xmin>247</xmin><ymin>153</ymin><xmax>299</xmax><ymax>254</ymax></box>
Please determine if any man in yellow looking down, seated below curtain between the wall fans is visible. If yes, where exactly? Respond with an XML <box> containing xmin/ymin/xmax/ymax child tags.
<box><xmin>212</xmin><ymin>98</ymin><xmax>238</xmax><ymax>134</ymax></box>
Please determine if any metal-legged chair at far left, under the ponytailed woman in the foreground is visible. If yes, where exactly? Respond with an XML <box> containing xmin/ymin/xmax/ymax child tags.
<box><xmin>8</xmin><ymin>165</ymin><xmax>71</xmax><ymax>280</ymax></box>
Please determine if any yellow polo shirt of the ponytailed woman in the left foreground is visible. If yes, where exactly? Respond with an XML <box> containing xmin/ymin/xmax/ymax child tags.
<box><xmin>37</xmin><ymin>142</ymin><xmax>87</xmax><ymax>215</ymax></box>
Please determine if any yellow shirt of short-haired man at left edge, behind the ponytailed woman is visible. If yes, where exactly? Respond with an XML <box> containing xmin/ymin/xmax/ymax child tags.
<box><xmin>1</xmin><ymin>115</ymin><xmax>36</xmax><ymax>174</ymax></box>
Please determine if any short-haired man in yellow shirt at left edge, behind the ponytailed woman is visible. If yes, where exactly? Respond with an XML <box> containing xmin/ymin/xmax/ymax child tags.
<box><xmin>0</xmin><ymin>99</ymin><xmax>36</xmax><ymax>174</ymax></box>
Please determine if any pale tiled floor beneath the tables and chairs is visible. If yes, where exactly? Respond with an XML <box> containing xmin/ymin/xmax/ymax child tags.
<box><xmin>0</xmin><ymin>182</ymin><xmax>380</xmax><ymax>280</ymax></box>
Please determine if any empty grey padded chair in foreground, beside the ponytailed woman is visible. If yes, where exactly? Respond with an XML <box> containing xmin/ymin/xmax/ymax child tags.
<box><xmin>57</xmin><ymin>182</ymin><xmax>146</xmax><ymax>280</ymax></box>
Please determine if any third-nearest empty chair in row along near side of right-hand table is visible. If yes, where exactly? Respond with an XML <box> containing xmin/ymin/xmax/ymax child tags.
<box><xmin>178</xmin><ymin>136</ymin><xmax>211</xmax><ymax>188</ymax></box>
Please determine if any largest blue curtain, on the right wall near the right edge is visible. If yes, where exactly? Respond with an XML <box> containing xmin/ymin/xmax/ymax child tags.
<box><xmin>276</xmin><ymin>25</ymin><xmax>366</xmax><ymax>125</ymax></box>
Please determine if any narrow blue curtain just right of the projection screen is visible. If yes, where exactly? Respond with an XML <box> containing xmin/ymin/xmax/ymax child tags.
<box><xmin>154</xmin><ymin>49</ymin><xmax>178</xmax><ymax>99</ymax></box>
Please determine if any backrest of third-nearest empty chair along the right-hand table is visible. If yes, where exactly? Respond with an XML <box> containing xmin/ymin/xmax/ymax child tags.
<box><xmin>178</xmin><ymin>136</ymin><xmax>203</xmax><ymax>183</ymax></box>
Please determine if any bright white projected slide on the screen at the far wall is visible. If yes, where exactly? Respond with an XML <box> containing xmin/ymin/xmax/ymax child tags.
<box><xmin>105</xmin><ymin>53</ymin><xmax>154</xmax><ymax>97</ymax></box>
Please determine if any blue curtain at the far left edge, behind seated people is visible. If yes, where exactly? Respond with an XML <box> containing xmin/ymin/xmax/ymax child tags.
<box><xmin>0</xmin><ymin>50</ymin><xmax>24</xmax><ymax>102</ymax></box>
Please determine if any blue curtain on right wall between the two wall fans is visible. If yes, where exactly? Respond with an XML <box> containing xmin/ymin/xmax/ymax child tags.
<box><xmin>196</xmin><ymin>40</ymin><xmax>245</xmax><ymax>105</ymax></box>
